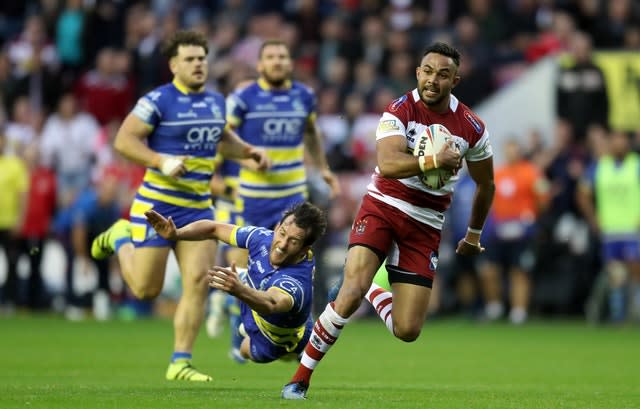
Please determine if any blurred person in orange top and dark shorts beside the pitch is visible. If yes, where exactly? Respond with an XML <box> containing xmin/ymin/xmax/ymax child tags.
<box><xmin>480</xmin><ymin>139</ymin><xmax>549</xmax><ymax>324</ymax></box>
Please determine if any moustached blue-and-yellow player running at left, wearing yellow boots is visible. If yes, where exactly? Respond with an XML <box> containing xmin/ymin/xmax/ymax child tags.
<box><xmin>91</xmin><ymin>31</ymin><xmax>269</xmax><ymax>381</ymax></box>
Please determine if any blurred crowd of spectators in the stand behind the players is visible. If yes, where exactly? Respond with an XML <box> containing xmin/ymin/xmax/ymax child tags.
<box><xmin>0</xmin><ymin>0</ymin><xmax>640</xmax><ymax>322</ymax></box>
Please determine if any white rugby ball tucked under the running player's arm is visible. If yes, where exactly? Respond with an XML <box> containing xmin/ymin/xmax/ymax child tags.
<box><xmin>413</xmin><ymin>124</ymin><xmax>453</xmax><ymax>190</ymax></box>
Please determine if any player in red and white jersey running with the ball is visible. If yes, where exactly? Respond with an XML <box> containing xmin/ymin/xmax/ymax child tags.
<box><xmin>282</xmin><ymin>43</ymin><xmax>494</xmax><ymax>399</ymax></box>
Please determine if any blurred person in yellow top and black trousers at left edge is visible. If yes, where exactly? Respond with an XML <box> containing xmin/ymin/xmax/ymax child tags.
<box><xmin>0</xmin><ymin>129</ymin><xmax>29</xmax><ymax>313</ymax></box>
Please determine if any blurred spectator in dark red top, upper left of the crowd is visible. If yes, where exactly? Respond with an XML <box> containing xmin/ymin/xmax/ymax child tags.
<box><xmin>74</xmin><ymin>48</ymin><xmax>135</xmax><ymax>125</ymax></box>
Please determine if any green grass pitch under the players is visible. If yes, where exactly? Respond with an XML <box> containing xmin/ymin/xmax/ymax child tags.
<box><xmin>0</xmin><ymin>315</ymin><xmax>640</xmax><ymax>409</ymax></box>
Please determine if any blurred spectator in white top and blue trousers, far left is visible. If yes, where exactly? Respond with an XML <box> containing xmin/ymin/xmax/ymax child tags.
<box><xmin>41</xmin><ymin>93</ymin><xmax>99</xmax><ymax>208</ymax></box>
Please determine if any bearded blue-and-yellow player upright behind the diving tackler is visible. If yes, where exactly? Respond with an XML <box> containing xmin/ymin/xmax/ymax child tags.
<box><xmin>227</xmin><ymin>40</ymin><xmax>340</xmax><ymax>228</ymax></box>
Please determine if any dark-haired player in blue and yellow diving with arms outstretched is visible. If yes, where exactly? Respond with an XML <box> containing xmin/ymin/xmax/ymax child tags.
<box><xmin>146</xmin><ymin>202</ymin><xmax>327</xmax><ymax>363</ymax></box>
